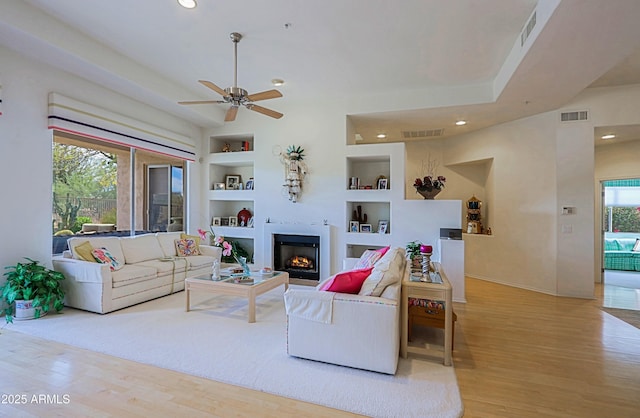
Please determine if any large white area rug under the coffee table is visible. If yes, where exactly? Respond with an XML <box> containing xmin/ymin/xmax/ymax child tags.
<box><xmin>9</xmin><ymin>288</ymin><xmax>463</xmax><ymax>417</ymax></box>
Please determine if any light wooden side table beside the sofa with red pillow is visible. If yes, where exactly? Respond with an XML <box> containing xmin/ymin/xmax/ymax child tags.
<box><xmin>400</xmin><ymin>263</ymin><xmax>453</xmax><ymax>366</ymax></box>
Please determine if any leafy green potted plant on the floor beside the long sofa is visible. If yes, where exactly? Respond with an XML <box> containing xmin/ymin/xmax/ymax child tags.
<box><xmin>0</xmin><ymin>257</ymin><xmax>64</xmax><ymax>323</ymax></box>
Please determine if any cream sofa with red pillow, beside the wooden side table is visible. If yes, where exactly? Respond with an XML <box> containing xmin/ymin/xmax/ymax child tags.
<box><xmin>285</xmin><ymin>247</ymin><xmax>410</xmax><ymax>374</ymax></box>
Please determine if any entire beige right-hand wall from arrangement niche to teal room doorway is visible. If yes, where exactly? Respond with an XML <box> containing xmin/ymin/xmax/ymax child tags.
<box><xmin>407</xmin><ymin>82</ymin><xmax>640</xmax><ymax>298</ymax></box>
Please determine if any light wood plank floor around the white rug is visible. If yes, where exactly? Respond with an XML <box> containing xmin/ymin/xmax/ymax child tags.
<box><xmin>0</xmin><ymin>279</ymin><xmax>640</xmax><ymax>418</ymax></box>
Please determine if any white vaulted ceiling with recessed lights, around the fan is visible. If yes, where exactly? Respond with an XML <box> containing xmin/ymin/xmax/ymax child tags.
<box><xmin>0</xmin><ymin>0</ymin><xmax>640</xmax><ymax>142</ymax></box>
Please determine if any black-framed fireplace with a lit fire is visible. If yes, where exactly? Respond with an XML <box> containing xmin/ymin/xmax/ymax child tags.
<box><xmin>273</xmin><ymin>234</ymin><xmax>320</xmax><ymax>280</ymax></box>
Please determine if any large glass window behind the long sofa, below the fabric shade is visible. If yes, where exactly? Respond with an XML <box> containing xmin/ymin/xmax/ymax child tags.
<box><xmin>52</xmin><ymin>130</ymin><xmax>186</xmax><ymax>248</ymax></box>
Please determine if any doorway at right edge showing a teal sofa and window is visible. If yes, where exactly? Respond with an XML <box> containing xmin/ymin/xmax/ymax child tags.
<box><xmin>601</xmin><ymin>178</ymin><xmax>640</xmax><ymax>310</ymax></box>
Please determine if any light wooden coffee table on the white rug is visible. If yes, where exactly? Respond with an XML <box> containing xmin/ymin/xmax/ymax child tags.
<box><xmin>184</xmin><ymin>271</ymin><xmax>289</xmax><ymax>323</ymax></box>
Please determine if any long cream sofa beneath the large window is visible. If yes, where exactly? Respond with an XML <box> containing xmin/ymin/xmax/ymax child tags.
<box><xmin>53</xmin><ymin>232</ymin><xmax>222</xmax><ymax>314</ymax></box>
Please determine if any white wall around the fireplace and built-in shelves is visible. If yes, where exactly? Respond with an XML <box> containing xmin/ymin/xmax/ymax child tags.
<box><xmin>200</xmin><ymin>100</ymin><xmax>461</xmax><ymax>273</ymax></box>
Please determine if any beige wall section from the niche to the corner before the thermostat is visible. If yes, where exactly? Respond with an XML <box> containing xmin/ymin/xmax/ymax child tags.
<box><xmin>436</xmin><ymin>114</ymin><xmax>556</xmax><ymax>294</ymax></box>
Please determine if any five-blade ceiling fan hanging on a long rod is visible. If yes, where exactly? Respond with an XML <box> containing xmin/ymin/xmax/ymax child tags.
<box><xmin>178</xmin><ymin>32</ymin><xmax>284</xmax><ymax>122</ymax></box>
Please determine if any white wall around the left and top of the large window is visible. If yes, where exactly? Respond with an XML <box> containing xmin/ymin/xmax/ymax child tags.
<box><xmin>0</xmin><ymin>46</ymin><xmax>201</xmax><ymax>274</ymax></box>
